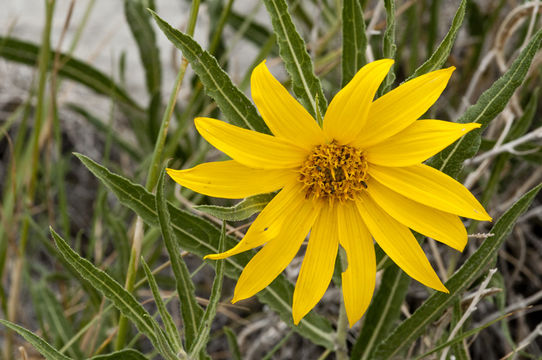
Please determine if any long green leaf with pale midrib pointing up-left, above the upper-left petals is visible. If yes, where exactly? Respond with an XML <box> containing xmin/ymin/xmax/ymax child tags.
<box><xmin>151</xmin><ymin>11</ymin><xmax>269</xmax><ymax>133</ymax></box>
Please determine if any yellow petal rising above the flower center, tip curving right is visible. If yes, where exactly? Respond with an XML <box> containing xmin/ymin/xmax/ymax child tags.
<box><xmin>324</xmin><ymin>59</ymin><xmax>393</xmax><ymax>144</ymax></box>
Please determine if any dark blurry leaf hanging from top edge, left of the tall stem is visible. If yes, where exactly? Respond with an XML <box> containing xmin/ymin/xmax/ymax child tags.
<box><xmin>124</xmin><ymin>0</ymin><xmax>162</xmax><ymax>94</ymax></box>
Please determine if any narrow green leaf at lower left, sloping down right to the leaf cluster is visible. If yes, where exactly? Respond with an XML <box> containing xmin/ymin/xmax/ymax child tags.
<box><xmin>50</xmin><ymin>228</ymin><xmax>172</xmax><ymax>354</ymax></box>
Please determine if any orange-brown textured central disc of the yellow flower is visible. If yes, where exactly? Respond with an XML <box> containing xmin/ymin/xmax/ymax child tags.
<box><xmin>298</xmin><ymin>140</ymin><xmax>367</xmax><ymax>202</ymax></box>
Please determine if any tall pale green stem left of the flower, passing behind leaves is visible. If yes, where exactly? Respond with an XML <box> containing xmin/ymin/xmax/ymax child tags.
<box><xmin>115</xmin><ymin>0</ymin><xmax>200</xmax><ymax>350</ymax></box>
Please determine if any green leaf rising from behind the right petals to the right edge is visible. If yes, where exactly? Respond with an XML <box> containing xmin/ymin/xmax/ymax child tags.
<box><xmin>429</xmin><ymin>29</ymin><xmax>542</xmax><ymax>177</ymax></box>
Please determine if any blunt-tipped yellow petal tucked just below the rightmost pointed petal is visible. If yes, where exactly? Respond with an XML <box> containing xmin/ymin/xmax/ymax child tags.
<box><xmin>367</xmin><ymin>178</ymin><xmax>467</xmax><ymax>251</ymax></box>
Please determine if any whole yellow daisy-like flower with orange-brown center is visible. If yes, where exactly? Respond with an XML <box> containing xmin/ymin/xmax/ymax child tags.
<box><xmin>168</xmin><ymin>59</ymin><xmax>491</xmax><ymax>326</ymax></box>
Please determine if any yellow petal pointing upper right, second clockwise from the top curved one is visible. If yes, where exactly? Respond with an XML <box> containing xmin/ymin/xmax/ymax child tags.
<box><xmin>353</xmin><ymin>66</ymin><xmax>455</xmax><ymax>148</ymax></box>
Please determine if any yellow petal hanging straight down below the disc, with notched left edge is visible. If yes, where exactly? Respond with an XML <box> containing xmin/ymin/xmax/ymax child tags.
<box><xmin>338</xmin><ymin>201</ymin><xmax>376</xmax><ymax>327</ymax></box>
